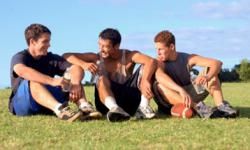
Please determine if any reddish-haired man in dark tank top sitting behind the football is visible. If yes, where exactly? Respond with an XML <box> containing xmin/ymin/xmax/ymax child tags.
<box><xmin>151</xmin><ymin>31</ymin><xmax>238</xmax><ymax>118</ymax></box>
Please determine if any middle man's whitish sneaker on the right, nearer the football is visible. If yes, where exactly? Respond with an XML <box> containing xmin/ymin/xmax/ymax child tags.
<box><xmin>135</xmin><ymin>106</ymin><xmax>155</xmax><ymax>119</ymax></box>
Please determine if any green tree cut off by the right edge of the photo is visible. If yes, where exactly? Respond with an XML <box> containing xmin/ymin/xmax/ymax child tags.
<box><xmin>237</xmin><ymin>59</ymin><xmax>250</xmax><ymax>81</ymax></box>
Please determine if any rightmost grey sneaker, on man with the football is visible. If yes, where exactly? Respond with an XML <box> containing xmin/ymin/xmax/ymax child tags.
<box><xmin>217</xmin><ymin>100</ymin><xmax>239</xmax><ymax>118</ymax></box>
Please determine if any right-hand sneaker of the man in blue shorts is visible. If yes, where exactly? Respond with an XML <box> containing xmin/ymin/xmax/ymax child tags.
<box><xmin>79</xmin><ymin>103</ymin><xmax>102</xmax><ymax>121</ymax></box>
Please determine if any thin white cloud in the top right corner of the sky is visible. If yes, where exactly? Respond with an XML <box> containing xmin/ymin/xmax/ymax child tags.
<box><xmin>192</xmin><ymin>0</ymin><xmax>250</xmax><ymax>19</ymax></box>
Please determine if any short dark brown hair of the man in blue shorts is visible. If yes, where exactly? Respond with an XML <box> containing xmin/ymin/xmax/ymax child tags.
<box><xmin>24</xmin><ymin>23</ymin><xmax>51</xmax><ymax>45</ymax></box>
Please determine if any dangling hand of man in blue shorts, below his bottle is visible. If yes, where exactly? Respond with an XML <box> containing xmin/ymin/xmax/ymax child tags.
<box><xmin>69</xmin><ymin>84</ymin><xmax>83</xmax><ymax>102</ymax></box>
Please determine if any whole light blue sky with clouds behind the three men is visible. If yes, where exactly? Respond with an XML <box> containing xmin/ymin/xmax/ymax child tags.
<box><xmin>0</xmin><ymin>0</ymin><xmax>250</xmax><ymax>88</ymax></box>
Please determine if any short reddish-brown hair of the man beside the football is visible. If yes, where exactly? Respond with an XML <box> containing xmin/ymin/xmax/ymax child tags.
<box><xmin>154</xmin><ymin>30</ymin><xmax>175</xmax><ymax>47</ymax></box>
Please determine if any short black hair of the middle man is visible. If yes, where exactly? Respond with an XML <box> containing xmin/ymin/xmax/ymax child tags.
<box><xmin>99</xmin><ymin>28</ymin><xmax>122</xmax><ymax>46</ymax></box>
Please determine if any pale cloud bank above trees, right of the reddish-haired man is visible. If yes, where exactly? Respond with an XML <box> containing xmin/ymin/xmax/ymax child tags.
<box><xmin>174</xmin><ymin>28</ymin><xmax>250</xmax><ymax>68</ymax></box>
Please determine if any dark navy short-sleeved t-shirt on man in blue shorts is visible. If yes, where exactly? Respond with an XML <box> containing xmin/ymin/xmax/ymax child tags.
<box><xmin>10</xmin><ymin>49</ymin><xmax>71</xmax><ymax>94</ymax></box>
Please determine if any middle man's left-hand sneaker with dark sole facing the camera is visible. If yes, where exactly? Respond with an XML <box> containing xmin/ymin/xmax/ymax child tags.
<box><xmin>107</xmin><ymin>107</ymin><xmax>130</xmax><ymax>122</ymax></box>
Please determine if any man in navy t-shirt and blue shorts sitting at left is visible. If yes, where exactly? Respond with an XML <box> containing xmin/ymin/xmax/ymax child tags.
<box><xmin>9</xmin><ymin>24</ymin><xmax>100</xmax><ymax>122</ymax></box>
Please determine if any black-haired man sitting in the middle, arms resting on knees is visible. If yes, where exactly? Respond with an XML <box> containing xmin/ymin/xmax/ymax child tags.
<box><xmin>64</xmin><ymin>28</ymin><xmax>156</xmax><ymax>122</ymax></box>
